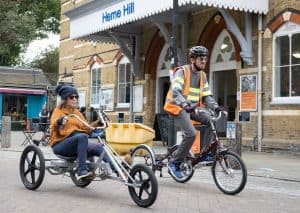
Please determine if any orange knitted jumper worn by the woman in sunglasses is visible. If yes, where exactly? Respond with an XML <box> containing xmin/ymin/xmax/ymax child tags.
<box><xmin>50</xmin><ymin>107</ymin><xmax>91</xmax><ymax>147</ymax></box>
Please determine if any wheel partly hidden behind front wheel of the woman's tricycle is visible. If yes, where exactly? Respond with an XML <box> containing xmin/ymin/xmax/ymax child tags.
<box><xmin>131</xmin><ymin>145</ymin><xmax>155</xmax><ymax>172</ymax></box>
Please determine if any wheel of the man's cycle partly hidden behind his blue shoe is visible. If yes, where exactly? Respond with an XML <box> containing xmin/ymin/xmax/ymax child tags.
<box><xmin>169</xmin><ymin>145</ymin><xmax>195</xmax><ymax>183</ymax></box>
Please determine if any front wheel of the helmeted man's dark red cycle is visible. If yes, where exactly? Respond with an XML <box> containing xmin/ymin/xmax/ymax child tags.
<box><xmin>211</xmin><ymin>151</ymin><xmax>247</xmax><ymax>195</ymax></box>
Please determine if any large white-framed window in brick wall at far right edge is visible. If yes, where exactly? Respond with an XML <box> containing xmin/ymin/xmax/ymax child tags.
<box><xmin>274</xmin><ymin>32</ymin><xmax>300</xmax><ymax>98</ymax></box>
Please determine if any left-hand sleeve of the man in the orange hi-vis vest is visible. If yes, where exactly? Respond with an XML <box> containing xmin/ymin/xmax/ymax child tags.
<box><xmin>171</xmin><ymin>68</ymin><xmax>187</xmax><ymax>106</ymax></box>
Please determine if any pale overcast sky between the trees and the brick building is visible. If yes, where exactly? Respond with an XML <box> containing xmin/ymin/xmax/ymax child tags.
<box><xmin>23</xmin><ymin>33</ymin><xmax>59</xmax><ymax>62</ymax></box>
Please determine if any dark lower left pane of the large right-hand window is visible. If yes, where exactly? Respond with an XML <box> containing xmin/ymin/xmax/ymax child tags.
<box><xmin>275</xmin><ymin>67</ymin><xmax>290</xmax><ymax>97</ymax></box>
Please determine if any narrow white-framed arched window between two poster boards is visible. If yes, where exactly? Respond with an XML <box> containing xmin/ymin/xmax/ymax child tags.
<box><xmin>118</xmin><ymin>58</ymin><xmax>131</xmax><ymax>105</ymax></box>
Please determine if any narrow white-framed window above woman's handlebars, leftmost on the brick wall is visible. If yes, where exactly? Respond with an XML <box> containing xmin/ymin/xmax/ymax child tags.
<box><xmin>91</xmin><ymin>66</ymin><xmax>101</xmax><ymax>107</ymax></box>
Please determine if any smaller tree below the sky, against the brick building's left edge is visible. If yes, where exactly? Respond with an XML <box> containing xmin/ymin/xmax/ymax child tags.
<box><xmin>28</xmin><ymin>46</ymin><xmax>59</xmax><ymax>85</ymax></box>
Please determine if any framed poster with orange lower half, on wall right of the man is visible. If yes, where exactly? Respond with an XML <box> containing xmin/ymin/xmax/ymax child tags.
<box><xmin>240</xmin><ymin>75</ymin><xmax>257</xmax><ymax>111</ymax></box>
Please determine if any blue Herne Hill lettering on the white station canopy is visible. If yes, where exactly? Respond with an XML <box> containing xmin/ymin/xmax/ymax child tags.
<box><xmin>102</xmin><ymin>2</ymin><xmax>134</xmax><ymax>23</ymax></box>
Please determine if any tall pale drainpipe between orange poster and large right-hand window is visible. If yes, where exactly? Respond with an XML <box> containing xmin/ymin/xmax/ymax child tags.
<box><xmin>257</xmin><ymin>14</ymin><xmax>263</xmax><ymax>152</ymax></box>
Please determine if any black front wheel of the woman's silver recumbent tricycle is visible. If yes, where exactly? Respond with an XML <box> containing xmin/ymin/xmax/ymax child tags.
<box><xmin>128</xmin><ymin>164</ymin><xmax>158</xmax><ymax>208</ymax></box>
